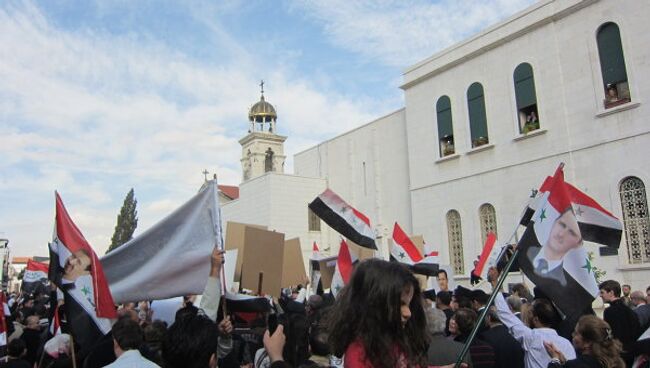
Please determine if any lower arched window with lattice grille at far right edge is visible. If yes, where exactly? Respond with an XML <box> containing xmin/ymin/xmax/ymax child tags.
<box><xmin>619</xmin><ymin>176</ymin><xmax>650</xmax><ymax>263</ymax></box>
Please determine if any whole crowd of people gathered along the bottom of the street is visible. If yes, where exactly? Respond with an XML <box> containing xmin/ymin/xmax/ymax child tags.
<box><xmin>0</xmin><ymin>253</ymin><xmax>650</xmax><ymax>368</ymax></box>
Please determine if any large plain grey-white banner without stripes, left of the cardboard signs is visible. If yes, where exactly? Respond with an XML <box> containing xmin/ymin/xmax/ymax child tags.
<box><xmin>102</xmin><ymin>180</ymin><xmax>224</xmax><ymax>303</ymax></box>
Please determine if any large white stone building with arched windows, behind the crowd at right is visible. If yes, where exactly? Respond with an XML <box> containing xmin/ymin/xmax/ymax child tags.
<box><xmin>223</xmin><ymin>0</ymin><xmax>650</xmax><ymax>290</ymax></box>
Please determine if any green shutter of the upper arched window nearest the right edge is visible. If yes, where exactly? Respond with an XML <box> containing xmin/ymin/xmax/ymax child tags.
<box><xmin>596</xmin><ymin>23</ymin><xmax>627</xmax><ymax>85</ymax></box>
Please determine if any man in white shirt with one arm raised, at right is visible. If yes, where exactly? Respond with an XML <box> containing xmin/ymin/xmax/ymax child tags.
<box><xmin>490</xmin><ymin>268</ymin><xmax>576</xmax><ymax>368</ymax></box>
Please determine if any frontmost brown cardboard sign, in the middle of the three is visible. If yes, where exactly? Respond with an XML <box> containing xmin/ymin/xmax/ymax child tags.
<box><xmin>241</xmin><ymin>226</ymin><xmax>284</xmax><ymax>298</ymax></box>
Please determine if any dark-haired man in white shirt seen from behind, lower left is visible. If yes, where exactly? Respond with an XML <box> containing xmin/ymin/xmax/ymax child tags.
<box><xmin>105</xmin><ymin>316</ymin><xmax>160</xmax><ymax>368</ymax></box>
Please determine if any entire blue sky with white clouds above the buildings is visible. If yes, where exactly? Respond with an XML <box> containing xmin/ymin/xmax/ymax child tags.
<box><xmin>0</xmin><ymin>0</ymin><xmax>532</xmax><ymax>256</ymax></box>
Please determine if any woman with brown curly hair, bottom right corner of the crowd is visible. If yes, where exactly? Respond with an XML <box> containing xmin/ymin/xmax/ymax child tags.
<box><xmin>544</xmin><ymin>315</ymin><xmax>625</xmax><ymax>368</ymax></box>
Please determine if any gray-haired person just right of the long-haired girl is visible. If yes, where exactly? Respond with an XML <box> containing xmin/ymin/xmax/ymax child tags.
<box><xmin>424</xmin><ymin>308</ymin><xmax>472</xmax><ymax>367</ymax></box>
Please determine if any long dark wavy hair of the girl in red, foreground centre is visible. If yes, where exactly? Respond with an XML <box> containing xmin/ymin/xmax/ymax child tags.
<box><xmin>329</xmin><ymin>258</ymin><xmax>427</xmax><ymax>368</ymax></box>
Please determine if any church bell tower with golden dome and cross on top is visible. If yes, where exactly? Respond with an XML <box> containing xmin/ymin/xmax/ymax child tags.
<box><xmin>239</xmin><ymin>81</ymin><xmax>287</xmax><ymax>181</ymax></box>
